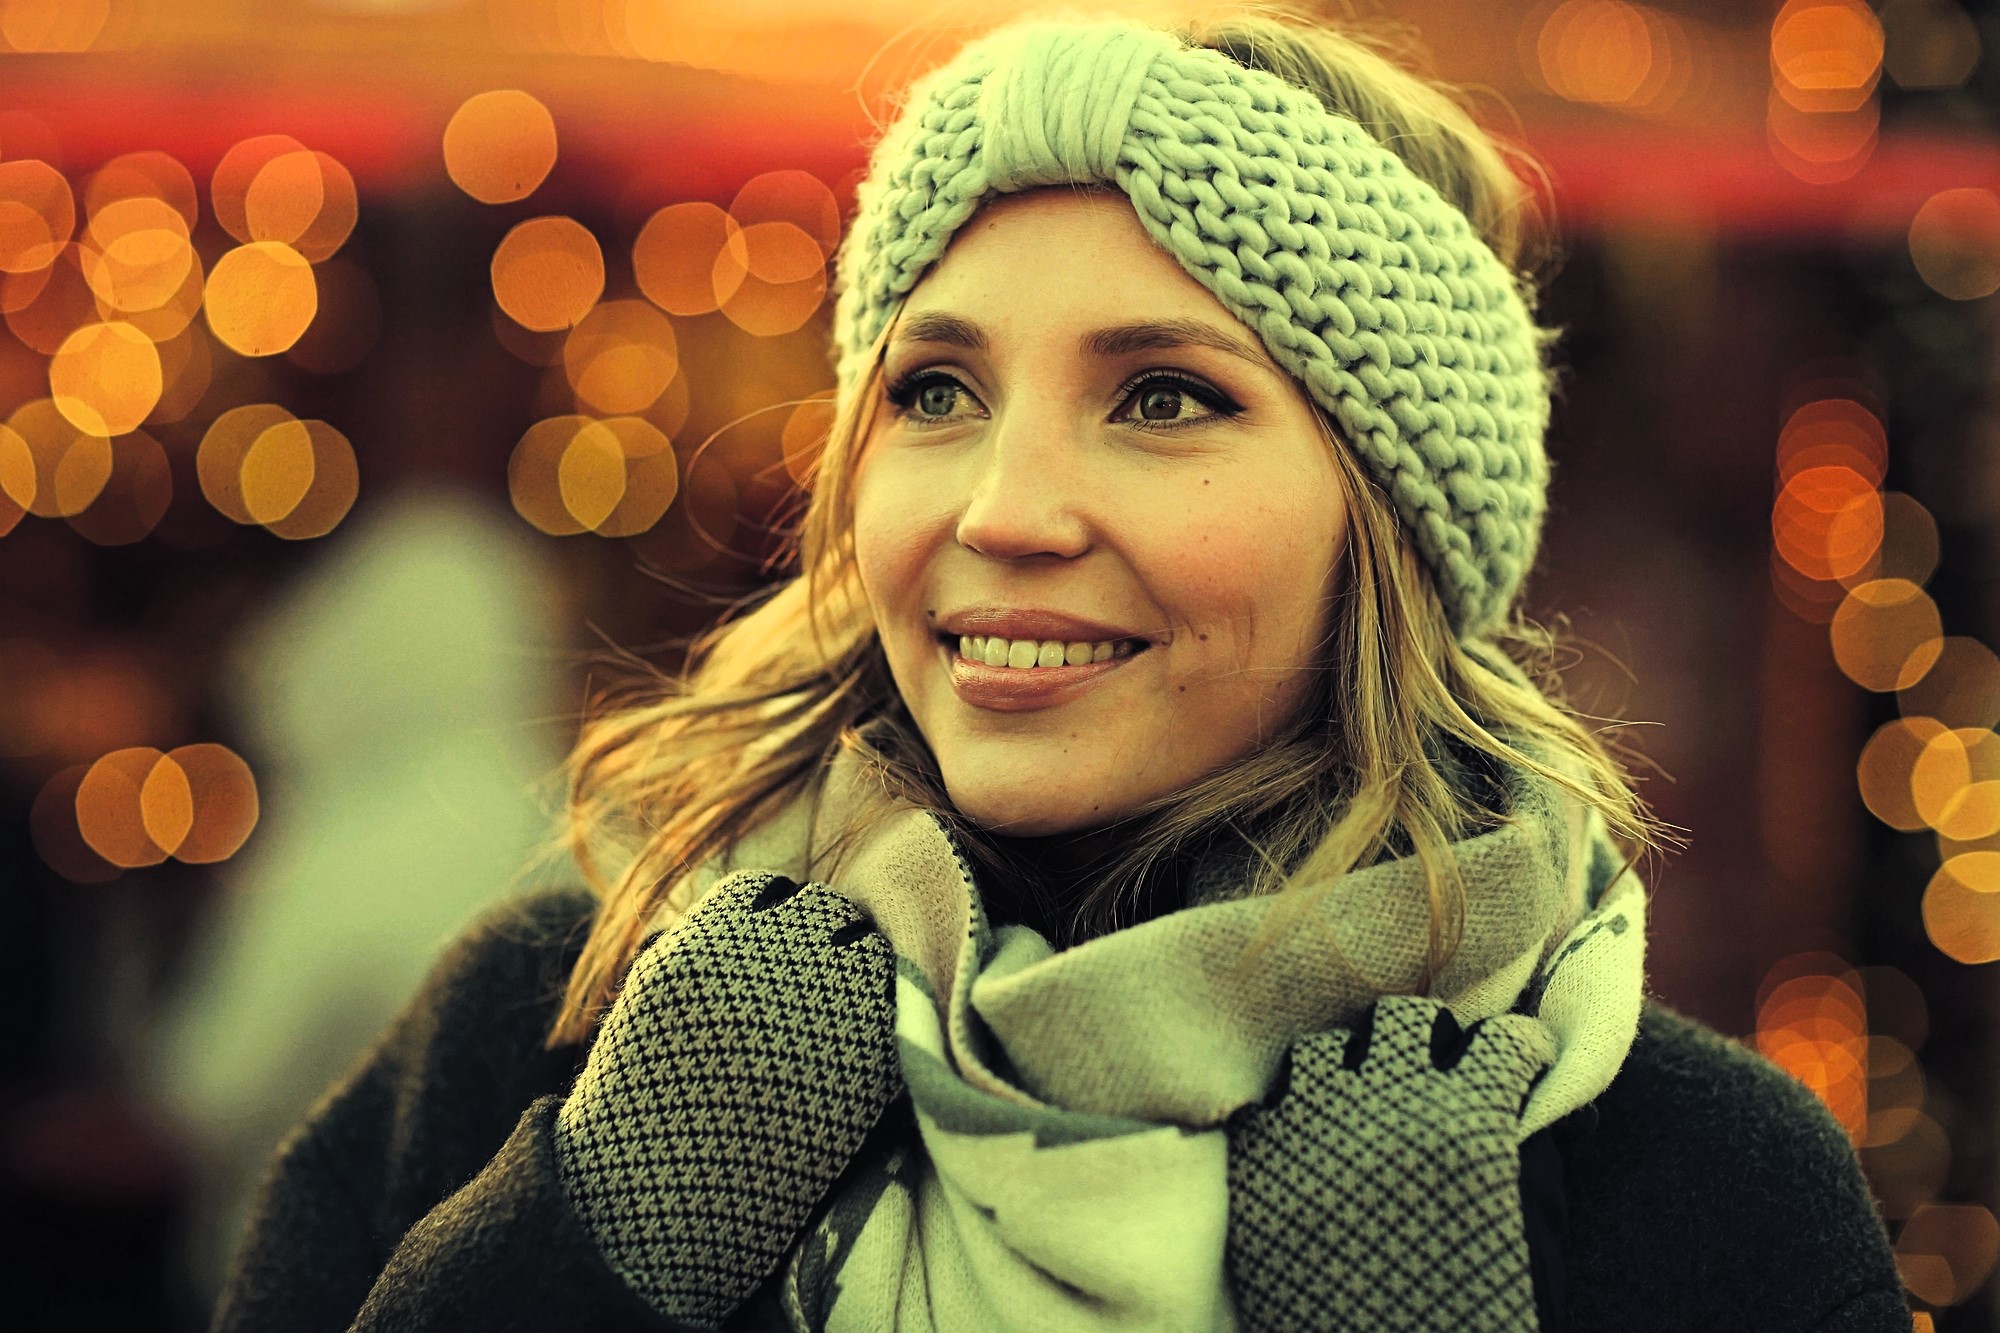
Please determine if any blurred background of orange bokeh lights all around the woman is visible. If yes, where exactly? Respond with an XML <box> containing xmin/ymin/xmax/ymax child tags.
<box><xmin>0</xmin><ymin>0</ymin><xmax>2000</xmax><ymax>1331</ymax></box>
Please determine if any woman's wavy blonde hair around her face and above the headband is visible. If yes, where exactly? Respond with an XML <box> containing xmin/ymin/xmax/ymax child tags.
<box><xmin>548</xmin><ymin>6</ymin><xmax>1662</xmax><ymax>1047</ymax></box>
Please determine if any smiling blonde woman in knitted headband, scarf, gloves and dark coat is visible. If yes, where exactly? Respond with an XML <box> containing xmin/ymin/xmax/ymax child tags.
<box><xmin>218</xmin><ymin>10</ymin><xmax>1910</xmax><ymax>1331</ymax></box>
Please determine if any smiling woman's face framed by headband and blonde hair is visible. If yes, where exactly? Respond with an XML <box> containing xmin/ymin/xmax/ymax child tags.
<box><xmin>854</xmin><ymin>188</ymin><xmax>1346</xmax><ymax>837</ymax></box>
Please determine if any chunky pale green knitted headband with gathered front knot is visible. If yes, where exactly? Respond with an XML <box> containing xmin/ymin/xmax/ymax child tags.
<box><xmin>834</xmin><ymin>20</ymin><xmax>1550</xmax><ymax>638</ymax></box>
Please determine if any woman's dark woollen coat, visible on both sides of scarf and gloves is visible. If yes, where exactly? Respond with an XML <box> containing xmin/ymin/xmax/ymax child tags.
<box><xmin>214</xmin><ymin>891</ymin><xmax>1910</xmax><ymax>1333</ymax></box>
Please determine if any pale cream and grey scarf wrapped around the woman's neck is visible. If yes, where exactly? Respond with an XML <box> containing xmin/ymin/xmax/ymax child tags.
<box><xmin>694</xmin><ymin>732</ymin><xmax>1646</xmax><ymax>1333</ymax></box>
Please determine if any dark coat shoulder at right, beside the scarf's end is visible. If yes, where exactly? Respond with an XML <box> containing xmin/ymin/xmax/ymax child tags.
<box><xmin>1564</xmin><ymin>1001</ymin><xmax>1908</xmax><ymax>1329</ymax></box>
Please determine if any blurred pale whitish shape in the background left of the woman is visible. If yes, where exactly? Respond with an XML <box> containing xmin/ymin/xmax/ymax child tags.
<box><xmin>150</xmin><ymin>490</ymin><xmax>568</xmax><ymax>1295</ymax></box>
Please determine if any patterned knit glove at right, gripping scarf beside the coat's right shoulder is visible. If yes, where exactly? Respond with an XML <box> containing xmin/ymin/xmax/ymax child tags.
<box><xmin>1224</xmin><ymin>995</ymin><xmax>1556</xmax><ymax>1333</ymax></box>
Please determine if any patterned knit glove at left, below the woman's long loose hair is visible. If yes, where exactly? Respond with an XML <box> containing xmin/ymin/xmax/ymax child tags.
<box><xmin>554</xmin><ymin>871</ymin><xmax>902</xmax><ymax>1325</ymax></box>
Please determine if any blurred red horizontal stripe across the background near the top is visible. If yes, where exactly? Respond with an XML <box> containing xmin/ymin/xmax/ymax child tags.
<box><xmin>0</xmin><ymin>82</ymin><xmax>2000</xmax><ymax>238</ymax></box>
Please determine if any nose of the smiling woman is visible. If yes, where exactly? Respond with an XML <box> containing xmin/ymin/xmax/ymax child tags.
<box><xmin>956</xmin><ymin>408</ymin><xmax>1090</xmax><ymax>560</ymax></box>
